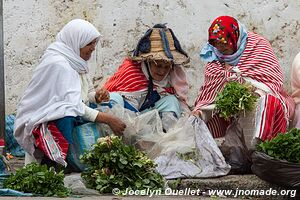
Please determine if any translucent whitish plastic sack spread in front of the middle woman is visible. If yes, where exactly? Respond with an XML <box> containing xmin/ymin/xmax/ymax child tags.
<box><xmin>102</xmin><ymin>105</ymin><xmax>230</xmax><ymax>179</ymax></box>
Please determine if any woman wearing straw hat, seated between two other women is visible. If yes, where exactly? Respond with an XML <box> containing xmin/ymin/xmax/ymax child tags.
<box><xmin>104</xmin><ymin>24</ymin><xmax>189</xmax><ymax>131</ymax></box>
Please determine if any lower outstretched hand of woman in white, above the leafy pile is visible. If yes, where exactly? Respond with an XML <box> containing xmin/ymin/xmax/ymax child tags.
<box><xmin>96</xmin><ymin>112</ymin><xmax>126</xmax><ymax>136</ymax></box>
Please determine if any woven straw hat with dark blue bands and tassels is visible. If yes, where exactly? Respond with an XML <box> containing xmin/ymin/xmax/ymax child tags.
<box><xmin>131</xmin><ymin>24</ymin><xmax>190</xmax><ymax>65</ymax></box>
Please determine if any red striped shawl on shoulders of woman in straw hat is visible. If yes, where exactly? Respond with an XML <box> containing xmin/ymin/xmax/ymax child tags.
<box><xmin>104</xmin><ymin>59</ymin><xmax>188</xmax><ymax>102</ymax></box>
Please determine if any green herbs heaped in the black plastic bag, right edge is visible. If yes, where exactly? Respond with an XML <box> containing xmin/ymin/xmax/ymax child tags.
<box><xmin>257</xmin><ymin>128</ymin><xmax>300</xmax><ymax>163</ymax></box>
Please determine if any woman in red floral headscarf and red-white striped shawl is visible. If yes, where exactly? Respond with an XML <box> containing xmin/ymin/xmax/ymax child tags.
<box><xmin>193</xmin><ymin>16</ymin><xmax>295</xmax><ymax>144</ymax></box>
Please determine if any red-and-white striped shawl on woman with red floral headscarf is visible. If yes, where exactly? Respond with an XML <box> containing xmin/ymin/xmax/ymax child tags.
<box><xmin>195</xmin><ymin>32</ymin><xmax>294</xmax><ymax>118</ymax></box>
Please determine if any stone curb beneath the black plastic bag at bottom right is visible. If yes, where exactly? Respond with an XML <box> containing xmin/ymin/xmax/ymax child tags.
<box><xmin>168</xmin><ymin>174</ymin><xmax>300</xmax><ymax>200</ymax></box>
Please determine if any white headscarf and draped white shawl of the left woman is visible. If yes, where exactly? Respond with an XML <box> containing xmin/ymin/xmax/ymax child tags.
<box><xmin>14</xmin><ymin>19</ymin><xmax>100</xmax><ymax>155</ymax></box>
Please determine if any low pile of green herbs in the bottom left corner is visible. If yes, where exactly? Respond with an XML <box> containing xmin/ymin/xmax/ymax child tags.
<box><xmin>3</xmin><ymin>163</ymin><xmax>70</xmax><ymax>197</ymax></box>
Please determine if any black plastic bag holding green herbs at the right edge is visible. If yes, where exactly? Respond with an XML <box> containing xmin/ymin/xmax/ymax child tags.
<box><xmin>251</xmin><ymin>151</ymin><xmax>300</xmax><ymax>189</ymax></box>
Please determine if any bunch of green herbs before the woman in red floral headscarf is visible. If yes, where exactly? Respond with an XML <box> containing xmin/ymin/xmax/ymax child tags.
<box><xmin>216</xmin><ymin>81</ymin><xmax>257</xmax><ymax>120</ymax></box>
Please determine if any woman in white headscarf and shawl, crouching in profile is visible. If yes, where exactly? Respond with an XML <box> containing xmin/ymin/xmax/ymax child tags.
<box><xmin>14</xmin><ymin>19</ymin><xmax>126</xmax><ymax>165</ymax></box>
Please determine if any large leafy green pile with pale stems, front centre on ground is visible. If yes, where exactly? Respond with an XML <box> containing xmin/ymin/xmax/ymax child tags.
<box><xmin>81</xmin><ymin>136</ymin><xmax>164</xmax><ymax>193</ymax></box>
